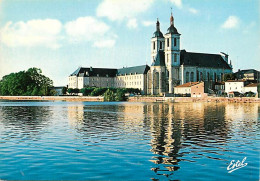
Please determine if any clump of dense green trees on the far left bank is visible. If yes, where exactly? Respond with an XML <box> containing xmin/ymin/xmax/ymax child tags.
<box><xmin>0</xmin><ymin>67</ymin><xmax>55</xmax><ymax>96</ymax></box>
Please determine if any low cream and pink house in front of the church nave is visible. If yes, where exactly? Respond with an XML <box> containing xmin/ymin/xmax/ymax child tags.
<box><xmin>174</xmin><ymin>82</ymin><xmax>205</xmax><ymax>97</ymax></box>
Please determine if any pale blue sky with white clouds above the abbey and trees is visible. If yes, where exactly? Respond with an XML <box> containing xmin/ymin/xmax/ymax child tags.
<box><xmin>0</xmin><ymin>0</ymin><xmax>260</xmax><ymax>86</ymax></box>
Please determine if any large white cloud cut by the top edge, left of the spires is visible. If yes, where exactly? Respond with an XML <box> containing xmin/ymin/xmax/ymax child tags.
<box><xmin>97</xmin><ymin>0</ymin><xmax>154</xmax><ymax>21</ymax></box>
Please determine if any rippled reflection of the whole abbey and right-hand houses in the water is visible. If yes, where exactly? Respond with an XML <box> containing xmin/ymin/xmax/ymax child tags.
<box><xmin>64</xmin><ymin>103</ymin><xmax>259</xmax><ymax>180</ymax></box>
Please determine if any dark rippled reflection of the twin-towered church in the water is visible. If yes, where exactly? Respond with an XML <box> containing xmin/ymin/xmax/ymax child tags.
<box><xmin>147</xmin><ymin>103</ymin><xmax>231</xmax><ymax>179</ymax></box>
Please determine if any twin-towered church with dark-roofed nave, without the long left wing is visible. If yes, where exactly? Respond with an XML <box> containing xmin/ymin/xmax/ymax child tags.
<box><xmin>147</xmin><ymin>14</ymin><xmax>232</xmax><ymax>94</ymax></box>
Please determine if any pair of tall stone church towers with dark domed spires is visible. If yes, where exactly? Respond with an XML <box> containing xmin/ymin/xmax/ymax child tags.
<box><xmin>148</xmin><ymin>14</ymin><xmax>181</xmax><ymax>94</ymax></box>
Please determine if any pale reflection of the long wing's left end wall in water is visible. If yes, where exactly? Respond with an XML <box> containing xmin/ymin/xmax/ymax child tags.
<box><xmin>68</xmin><ymin>104</ymin><xmax>84</xmax><ymax>126</ymax></box>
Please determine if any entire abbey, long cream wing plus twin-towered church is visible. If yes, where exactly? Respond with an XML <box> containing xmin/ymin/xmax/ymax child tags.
<box><xmin>68</xmin><ymin>14</ymin><xmax>232</xmax><ymax>95</ymax></box>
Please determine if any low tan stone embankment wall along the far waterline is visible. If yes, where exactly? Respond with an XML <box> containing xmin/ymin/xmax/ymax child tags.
<box><xmin>0</xmin><ymin>96</ymin><xmax>260</xmax><ymax>103</ymax></box>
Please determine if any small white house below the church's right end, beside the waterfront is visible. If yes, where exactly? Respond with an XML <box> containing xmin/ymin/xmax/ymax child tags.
<box><xmin>225</xmin><ymin>80</ymin><xmax>246</xmax><ymax>93</ymax></box>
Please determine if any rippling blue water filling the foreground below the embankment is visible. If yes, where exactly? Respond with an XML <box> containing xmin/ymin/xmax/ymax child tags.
<box><xmin>0</xmin><ymin>101</ymin><xmax>260</xmax><ymax>180</ymax></box>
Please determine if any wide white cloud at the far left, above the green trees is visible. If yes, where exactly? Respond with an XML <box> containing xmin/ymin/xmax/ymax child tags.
<box><xmin>0</xmin><ymin>19</ymin><xmax>62</xmax><ymax>49</ymax></box>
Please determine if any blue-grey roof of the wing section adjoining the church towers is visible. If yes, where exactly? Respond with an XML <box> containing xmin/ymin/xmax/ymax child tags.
<box><xmin>117</xmin><ymin>65</ymin><xmax>150</xmax><ymax>75</ymax></box>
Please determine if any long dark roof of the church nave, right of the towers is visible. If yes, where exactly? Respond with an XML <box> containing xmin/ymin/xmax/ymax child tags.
<box><xmin>180</xmin><ymin>50</ymin><xmax>232</xmax><ymax>69</ymax></box>
